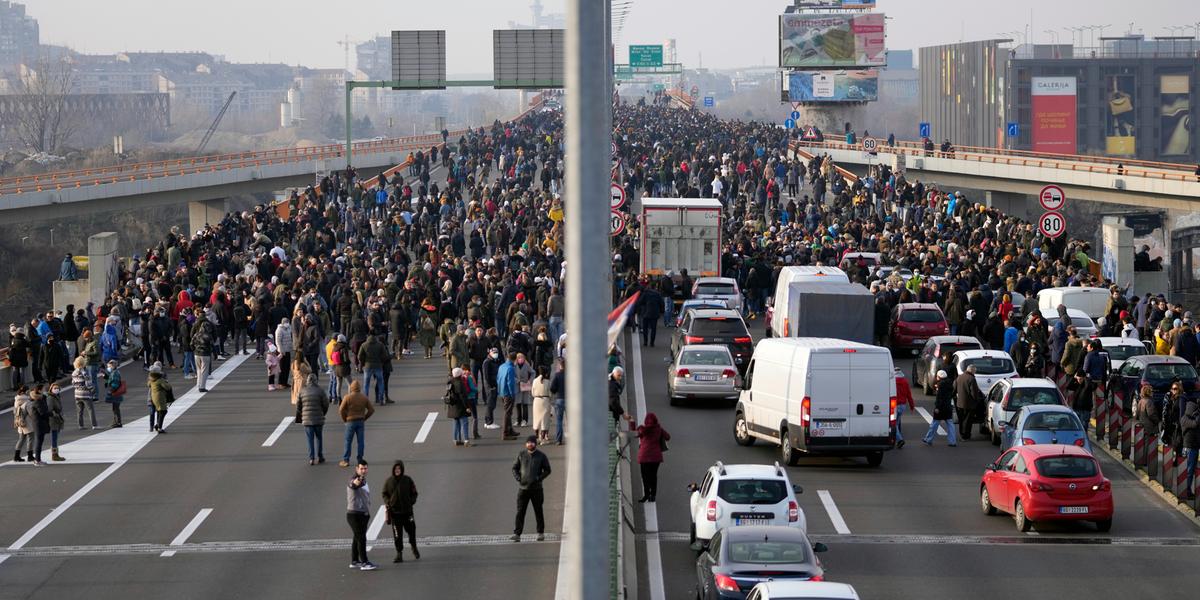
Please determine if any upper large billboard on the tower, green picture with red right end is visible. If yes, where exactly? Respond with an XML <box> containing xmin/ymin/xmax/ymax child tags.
<box><xmin>779</xmin><ymin>12</ymin><xmax>888</xmax><ymax>68</ymax></box>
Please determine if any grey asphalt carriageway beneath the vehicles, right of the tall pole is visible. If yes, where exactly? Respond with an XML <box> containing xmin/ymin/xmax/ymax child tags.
<box><xmin>625</xmin><ymin>323</ymin><xmax>1200</xmax><ymax>600</ymax></box>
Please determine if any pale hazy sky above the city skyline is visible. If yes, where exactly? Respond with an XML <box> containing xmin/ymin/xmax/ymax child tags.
<box><xmin>25</xmin><ymin>0</ymin><xmax>1185</xmax><ymax>73</ymax></box>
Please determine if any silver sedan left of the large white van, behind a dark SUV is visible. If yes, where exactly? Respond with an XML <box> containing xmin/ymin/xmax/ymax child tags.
<box><xmin>667</xmin><ymin>344</ymin><xmax>742</xmax><ymax>407</ymax></box>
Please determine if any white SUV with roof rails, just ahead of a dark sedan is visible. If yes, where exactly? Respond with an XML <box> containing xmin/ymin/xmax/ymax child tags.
<box><xmin>688</xmin><ymin>462</ymin><xmax>809</xmax><ymax>547</ymax></box>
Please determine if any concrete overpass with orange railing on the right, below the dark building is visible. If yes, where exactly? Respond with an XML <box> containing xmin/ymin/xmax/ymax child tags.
<box><xmin>792</xmin><ymin>140</ymin><xmax>1200</xmax><ymax>220</ymax></box>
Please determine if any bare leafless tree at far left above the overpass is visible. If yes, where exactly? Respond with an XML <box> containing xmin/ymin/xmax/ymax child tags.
<box><xmin>16</xmin><ymin>58</ymin><xmax>79</xmax><ymax>154</ymax></box>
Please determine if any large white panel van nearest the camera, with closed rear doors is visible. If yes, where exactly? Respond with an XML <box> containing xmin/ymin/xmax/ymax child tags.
<box><xmin>733</xmin><ymin>337</ymin><xmax>896</xmax><ymax>467</ymax></box>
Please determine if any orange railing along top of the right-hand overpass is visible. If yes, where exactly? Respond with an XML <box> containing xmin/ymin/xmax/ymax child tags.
<box><xmin>796</xmin><ymin>140</ymin><xmax>1196</xmax><ymax>181</ymax></box>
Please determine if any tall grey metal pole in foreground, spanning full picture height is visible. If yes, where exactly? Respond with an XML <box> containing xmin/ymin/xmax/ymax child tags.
<box><xmin>563</xmin><ymin>0</ymin><xmax>612</xmax><ymax>600</ymax></box>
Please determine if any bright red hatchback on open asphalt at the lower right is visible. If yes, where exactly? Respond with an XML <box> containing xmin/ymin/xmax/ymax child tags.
<box><xmin>979</xmin><ymin>444</ymin><xmax>1112</xmax><ymax>532</ymax></box>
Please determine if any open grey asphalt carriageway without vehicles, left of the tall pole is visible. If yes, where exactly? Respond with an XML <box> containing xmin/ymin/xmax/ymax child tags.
<box><xmin>0</xmin><ymin>356</ymin><xmax>565</xmax><ymax>599</ymax></box>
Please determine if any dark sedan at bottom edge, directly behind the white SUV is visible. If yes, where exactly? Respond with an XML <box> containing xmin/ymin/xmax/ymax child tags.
<box><xmin>696</xmin><ymin>526</ymin><xmax>826</xmax><ymax>600</ymax></box>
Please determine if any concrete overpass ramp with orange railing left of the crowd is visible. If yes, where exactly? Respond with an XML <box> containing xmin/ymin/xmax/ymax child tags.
<box><xmin>0</xmin><ymin>100</ymin><xmax>540</xmax><ymax>230</ymax></box>
